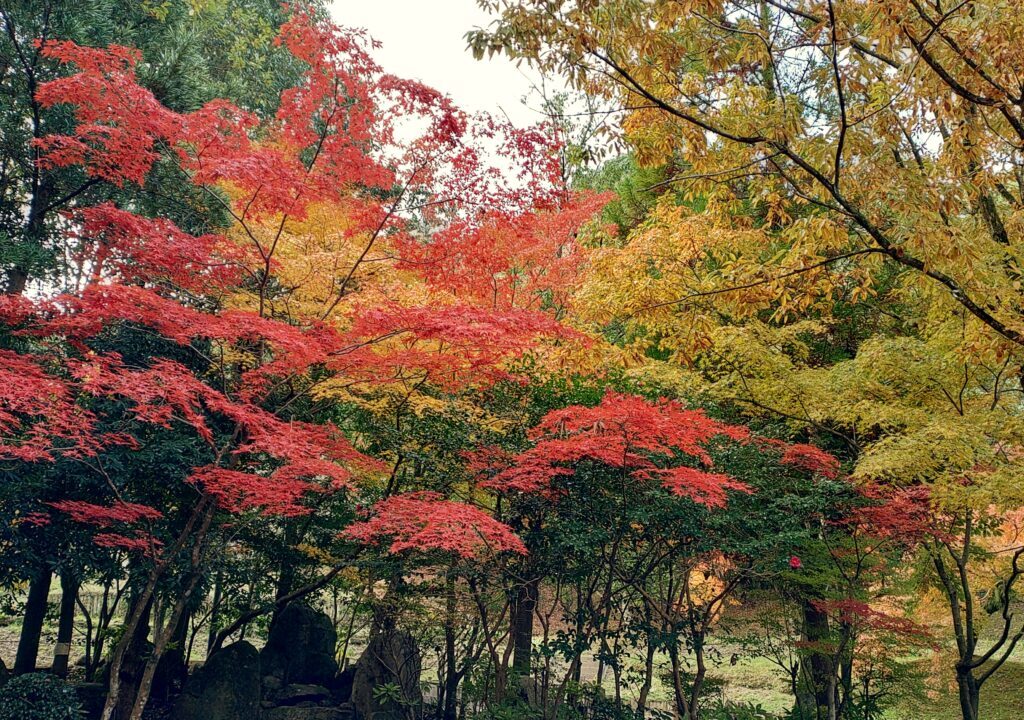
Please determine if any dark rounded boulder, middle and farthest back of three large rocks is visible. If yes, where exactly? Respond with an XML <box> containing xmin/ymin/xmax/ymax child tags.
<box><xmin>260</xmin><ymin>604</ymin><xmax>338</xmax><ymax>685</ymax></box>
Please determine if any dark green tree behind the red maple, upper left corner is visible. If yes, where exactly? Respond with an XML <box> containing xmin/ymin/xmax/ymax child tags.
<box><xmin>0</xmin><ymin>0</ymin><xmax>315</xmax><ymax>293</ymax></box>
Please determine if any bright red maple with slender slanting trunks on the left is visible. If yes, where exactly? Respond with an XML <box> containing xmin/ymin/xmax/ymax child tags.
<box><xmin>0</xmin><ymin>8</ymin><xmax>597</xmax><ymax>720</ymax></box>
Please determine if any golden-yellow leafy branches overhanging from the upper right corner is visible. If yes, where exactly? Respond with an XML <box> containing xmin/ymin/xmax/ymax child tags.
<box><xmin>479</xmin><ymin>0</ymin><xmax>1024</xmax><ymax>346</ymax></box>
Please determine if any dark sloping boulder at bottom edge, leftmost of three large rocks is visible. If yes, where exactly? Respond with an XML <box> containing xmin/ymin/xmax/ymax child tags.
<box><xmin>171</xmin><ymin>640</ymin><xmax>260</xmax><ymax>720</ymax></box>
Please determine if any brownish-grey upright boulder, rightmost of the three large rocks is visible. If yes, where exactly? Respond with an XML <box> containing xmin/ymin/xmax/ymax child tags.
<box><xmin>352</xmin><ymin>630</ymin><xmax>423</xmax><ymax>720</ymax></box>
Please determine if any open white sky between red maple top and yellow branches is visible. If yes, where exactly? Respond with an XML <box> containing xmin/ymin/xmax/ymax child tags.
<box><xmin>331</xmin><ymin>0</ymin><xmax>543</xmax><ymax>126</ymax></box>
